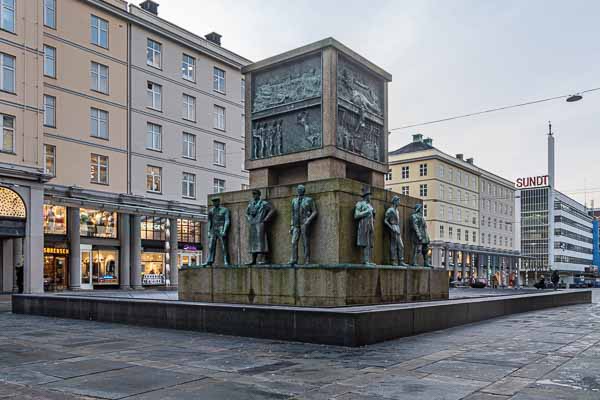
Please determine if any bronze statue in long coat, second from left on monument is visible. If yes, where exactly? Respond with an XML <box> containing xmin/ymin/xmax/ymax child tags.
<box><xmin>246</xmin><ymin>189</ymin><xmax>275</xmax><ymax>265</ymax></box>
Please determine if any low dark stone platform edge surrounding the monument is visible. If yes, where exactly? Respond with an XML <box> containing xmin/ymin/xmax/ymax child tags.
<box><xmin>12</xmin><ymin>290</ymin><xmax>592</xmax><ymax>347</ymax></box>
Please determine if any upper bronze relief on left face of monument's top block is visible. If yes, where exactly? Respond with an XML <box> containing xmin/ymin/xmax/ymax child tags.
<box><xmin>252</xmin><ymin>54</ymin><xmax>321</xmax><ymax>113</ymax></box>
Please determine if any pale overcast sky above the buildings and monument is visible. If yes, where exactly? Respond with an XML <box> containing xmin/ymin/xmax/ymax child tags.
<box><xmin>159</xmin><ymin>0</ymin><xmax>600</xmax><ymax>207</ymax></box>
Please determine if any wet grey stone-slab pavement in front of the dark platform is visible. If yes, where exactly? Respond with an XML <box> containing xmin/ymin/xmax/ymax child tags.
<box><xmin>0</xmin><ymin>290</ymin><xmax>600</xmax><ymax>400</ymax></box>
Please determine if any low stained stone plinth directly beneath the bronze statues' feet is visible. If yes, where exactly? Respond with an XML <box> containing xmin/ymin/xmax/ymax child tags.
<box><xmin>178</xmin><ymin>264</ymin><xmax>448</xmax><ymax>307</ymax></box>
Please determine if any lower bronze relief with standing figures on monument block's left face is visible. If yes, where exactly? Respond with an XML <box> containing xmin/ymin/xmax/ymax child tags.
<box><xmin>252</xmin><ymin>106</ymin><xmax>323</xmax><ymax>160</ymax></box>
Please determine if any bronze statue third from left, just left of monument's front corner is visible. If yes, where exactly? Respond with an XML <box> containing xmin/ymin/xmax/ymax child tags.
<box><xmin>290</xmin><ymin>185</ymin><xmax>317</xmax><ymax>265</ymax></box>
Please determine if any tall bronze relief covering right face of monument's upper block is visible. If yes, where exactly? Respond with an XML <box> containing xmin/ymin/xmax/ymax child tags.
<box><xmin>336</xmin><ymin>56</ymin><xmax>385</xmax><ymax>162</ymax></box>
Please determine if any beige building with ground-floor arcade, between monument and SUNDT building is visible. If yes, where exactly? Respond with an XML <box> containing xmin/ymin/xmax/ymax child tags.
<box><xmin>385</xmin><ymin>134</ymin><xmax>517</xmax><ymax>283</ymax></box>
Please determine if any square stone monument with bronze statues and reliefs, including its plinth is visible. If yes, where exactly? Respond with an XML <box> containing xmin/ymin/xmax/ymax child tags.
<box><xmin>179</xmin><ymin>38</ymin><xmax>448</xmax><ymax>306</ymax></box>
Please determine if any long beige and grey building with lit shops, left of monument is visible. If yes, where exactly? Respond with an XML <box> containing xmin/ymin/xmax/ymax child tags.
<box><xmin>0</xmin><ymin>0</ymin><xmax>248</xmax><ymax>292</ymax></box>
